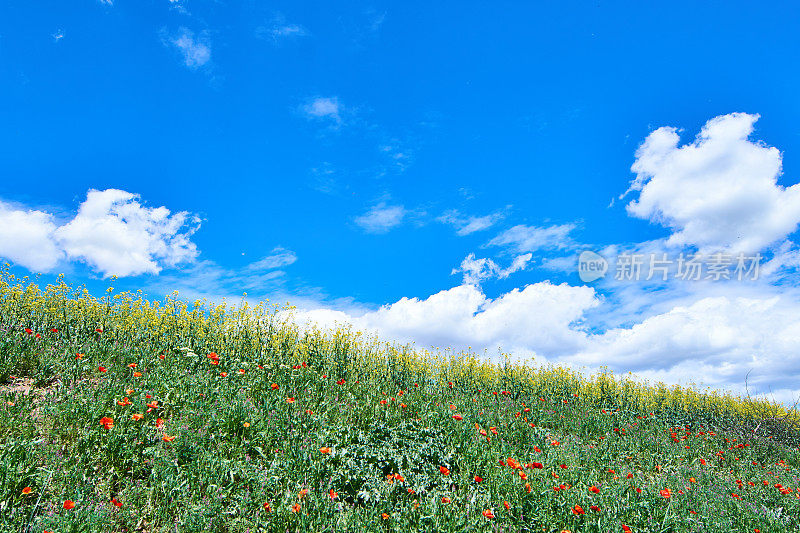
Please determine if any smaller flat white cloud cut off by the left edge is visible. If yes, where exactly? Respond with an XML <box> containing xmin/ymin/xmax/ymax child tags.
<box><xmin>0</xmin><ymin>202</ymin><xmax>63</xmax><ymax>272</ymax></box>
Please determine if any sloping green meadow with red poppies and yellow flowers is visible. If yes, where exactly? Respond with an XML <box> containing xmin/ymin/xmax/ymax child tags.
<box><xmin>0</xmin><ymin>272</ymin><xmax>800</xmax><ymax>533</ymax></box>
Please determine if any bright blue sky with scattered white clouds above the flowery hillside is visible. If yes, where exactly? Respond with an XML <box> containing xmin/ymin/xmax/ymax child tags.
<box><xmin>0</xmin><ymin>0</ymin><xmax>800</xmax><ymax>401</ymax></box>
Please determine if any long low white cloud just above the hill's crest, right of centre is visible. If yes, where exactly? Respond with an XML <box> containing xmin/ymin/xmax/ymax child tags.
<box><xmin>296</xmin><ymin>282</ymin><xmax>599</xmax><ymax>355</ymax></box>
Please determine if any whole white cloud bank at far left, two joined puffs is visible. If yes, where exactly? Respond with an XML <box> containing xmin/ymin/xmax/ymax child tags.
<box><xmin>0</xmin><ymin>189</ymin><xmax>199</xmax><ymax>277</ymax></box>
